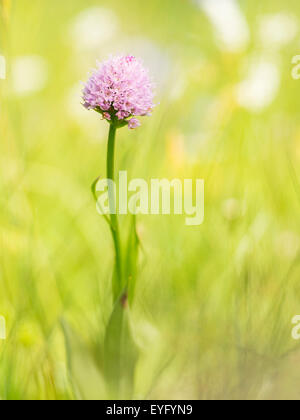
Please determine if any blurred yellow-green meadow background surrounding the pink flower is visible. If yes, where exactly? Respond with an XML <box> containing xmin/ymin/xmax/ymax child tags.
<box><xmin>0</xmin><ymin>0</ymin><xmax>300</xmax><ymax>399</ymax></box>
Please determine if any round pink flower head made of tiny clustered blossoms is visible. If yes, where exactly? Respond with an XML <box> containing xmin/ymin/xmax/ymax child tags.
<box><xmin>83</xmin><ymin>56</ymin><xmax>154</xmax><ymax>129</ymax></box>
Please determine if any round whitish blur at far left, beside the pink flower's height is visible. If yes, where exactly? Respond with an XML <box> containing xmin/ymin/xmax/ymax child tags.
<box><xmin>12</xmin><ymin>55</ymin><xmax>48</xmax><ymax>96</ymax></box>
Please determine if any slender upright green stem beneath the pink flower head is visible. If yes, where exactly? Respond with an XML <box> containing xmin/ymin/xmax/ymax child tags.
<box><xmin>107</xmin><ymin>123</ymin><xmax>122</xmax><ymax>298</ymax></box>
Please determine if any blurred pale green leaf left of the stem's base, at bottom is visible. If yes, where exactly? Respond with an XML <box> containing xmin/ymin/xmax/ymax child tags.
<box><xmin>61</xmin><ymin>320</ymin><xmax>107</xmax><ymax>400</ymax></box>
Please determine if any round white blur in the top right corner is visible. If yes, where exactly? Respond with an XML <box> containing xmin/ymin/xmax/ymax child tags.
<box><xmin>259</xmin><ymin>13</ymin><xmax>298</xmax><ymax>48</ymax></box>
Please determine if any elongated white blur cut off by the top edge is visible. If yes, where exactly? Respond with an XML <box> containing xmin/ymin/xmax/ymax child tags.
<box><xmin>197</xmin><ymin>0</ymin><xmax>250</xmax><ymax>52</ymax></box>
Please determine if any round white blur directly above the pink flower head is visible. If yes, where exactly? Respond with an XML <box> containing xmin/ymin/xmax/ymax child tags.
<box><xmin>70</xmin><ymin>7</ymin><xmax>119</xmax><ymax>49</ymax></box>
